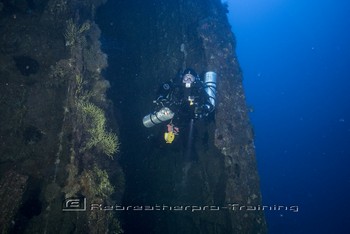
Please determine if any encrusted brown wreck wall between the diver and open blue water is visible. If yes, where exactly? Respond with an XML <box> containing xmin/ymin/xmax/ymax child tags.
<box><xmin>198</xmin><ymin>11</ymin><xmax>265</xmax><ymax>232</ymax></box>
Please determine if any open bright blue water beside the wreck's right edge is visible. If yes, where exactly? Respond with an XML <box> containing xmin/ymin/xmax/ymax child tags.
<box><xmin>228</xmin><ymin>0</ymin><xmax>350</xmax><ymax>234</ymax></box>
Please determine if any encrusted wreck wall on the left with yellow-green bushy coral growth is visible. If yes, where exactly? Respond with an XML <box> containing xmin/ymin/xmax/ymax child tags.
<box><xmin>0</xmin><ymin>0</ymin><xmax>123</xmax><ymax>233</ymax></box>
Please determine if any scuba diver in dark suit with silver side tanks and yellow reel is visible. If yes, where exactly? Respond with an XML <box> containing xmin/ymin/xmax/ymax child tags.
<box><xmin>143</xmin><ymin>68</ymin><xmax>216</xmax><ymax>144</ymax></box>
